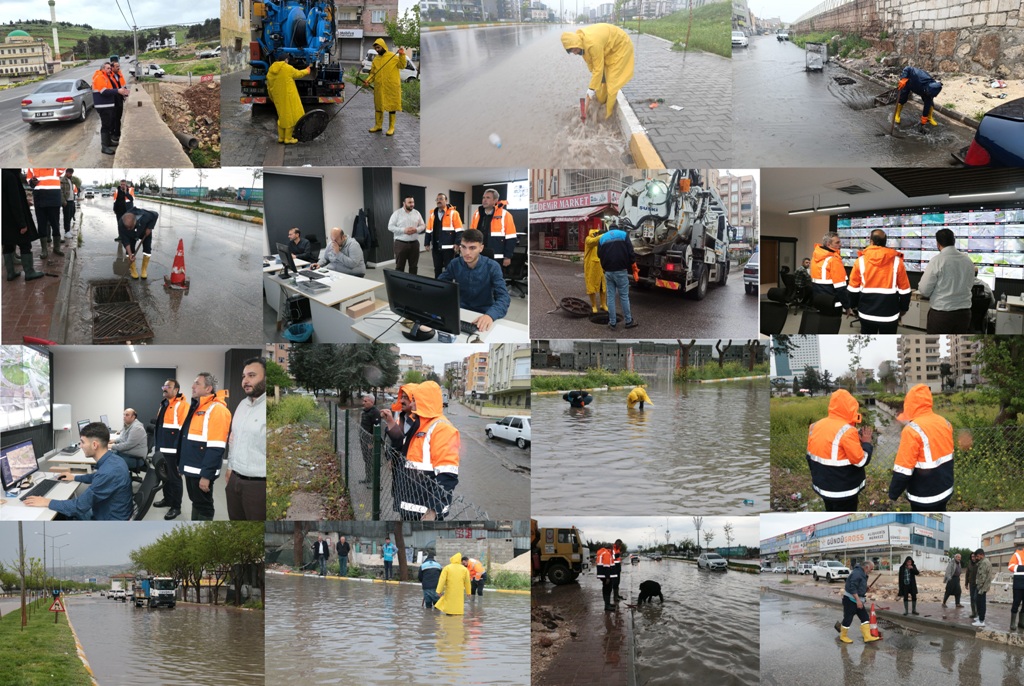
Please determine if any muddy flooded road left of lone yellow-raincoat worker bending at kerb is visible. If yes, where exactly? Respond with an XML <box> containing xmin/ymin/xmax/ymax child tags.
<box><xmin>420</xmin><ymin>25</ymin><xmax>632</xmax><ymax>169</ymax></box>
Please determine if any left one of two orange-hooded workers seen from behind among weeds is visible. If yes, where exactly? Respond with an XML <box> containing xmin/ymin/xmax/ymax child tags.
<box><xmin>807</xmin><ymin>389</ymin><xmax>872</xmax><ymax>512</ymax></box>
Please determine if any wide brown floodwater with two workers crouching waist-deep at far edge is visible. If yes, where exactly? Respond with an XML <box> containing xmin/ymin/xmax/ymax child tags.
<box><xmin>531</xmin><ymin>379</ymin><xmax>769</xmax><ymax>516</ymax></box>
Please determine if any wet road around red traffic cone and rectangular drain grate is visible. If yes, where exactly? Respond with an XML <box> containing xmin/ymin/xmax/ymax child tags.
<box><xmin>62</xmin><ymin>198</ymin><xmax>263</xmax><ymax>344</ymax></box>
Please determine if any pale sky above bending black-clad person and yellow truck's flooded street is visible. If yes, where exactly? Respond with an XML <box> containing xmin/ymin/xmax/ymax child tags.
<box><xmin>537</xmin><ymin>517</ymin><xmax>760</xmax><ymax>552</ymax></box>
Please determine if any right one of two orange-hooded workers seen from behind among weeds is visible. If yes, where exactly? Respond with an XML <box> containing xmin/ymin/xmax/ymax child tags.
<box><xmin>889</xmin><ymin>384</ymin><xmax>953</xmax><ymax>512</ymax></box>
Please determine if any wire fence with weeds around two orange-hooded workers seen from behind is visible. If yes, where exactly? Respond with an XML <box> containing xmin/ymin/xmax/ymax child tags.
<box><xmin>771</xmin><ymin>427</ymin><xmax>1024</xmax><ymax>511</ymax></box>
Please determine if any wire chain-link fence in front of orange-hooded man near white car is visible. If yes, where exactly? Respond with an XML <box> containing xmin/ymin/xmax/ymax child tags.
<box><xmin>332</xmin><ymin>408</ymin><xmax>489</xmax><ymax>521</ymax></box>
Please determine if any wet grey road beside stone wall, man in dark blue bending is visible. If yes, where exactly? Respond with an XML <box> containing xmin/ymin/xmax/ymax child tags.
<box><xmin>732</xmin><ymin>36</ymin><xmax>974</xmax><ymax>167</ymax></box>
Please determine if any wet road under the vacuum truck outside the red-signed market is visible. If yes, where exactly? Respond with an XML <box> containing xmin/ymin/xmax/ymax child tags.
<box><xmin>529</xmin><ymin>255</ymin><xmax>758</xmax><ymax>339</ymax></box>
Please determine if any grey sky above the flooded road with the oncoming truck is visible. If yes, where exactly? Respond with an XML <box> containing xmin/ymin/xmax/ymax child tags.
<box><xmin>0</xmin><ymin>521</ymin><xmax>178</xmax><ymax>566</ymax></box>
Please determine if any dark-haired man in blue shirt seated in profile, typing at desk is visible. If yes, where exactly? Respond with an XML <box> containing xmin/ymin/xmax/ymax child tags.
<box><xmin>25</xmin><ymin>422</ymin><xmax>132</xmax><ymax>521</ymax></box>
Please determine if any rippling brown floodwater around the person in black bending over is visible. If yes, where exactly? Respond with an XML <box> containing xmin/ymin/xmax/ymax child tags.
<box><xmin>622</xmin><ymin>558</ymin><xmax>760</xmax><ymax>686</ymax></box>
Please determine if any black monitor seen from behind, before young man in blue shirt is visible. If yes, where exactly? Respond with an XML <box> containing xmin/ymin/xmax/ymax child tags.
<box><xmin>384</xmin><ymin>269</ymin><xmax>460</xmax><ymax>341</ymax></box>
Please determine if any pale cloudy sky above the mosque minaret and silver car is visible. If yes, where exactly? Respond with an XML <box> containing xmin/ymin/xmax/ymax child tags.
<box><xmin>0</xmin><ymin>0</ymin><xmax>214</xmax><ymax>31</ymax></box>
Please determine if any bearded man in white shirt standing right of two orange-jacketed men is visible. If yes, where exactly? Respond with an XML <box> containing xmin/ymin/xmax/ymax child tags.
<box><xmin>224</xmin><ymin>357</ymin><xmax>266</xmax><ymax>521</ymax></box>
